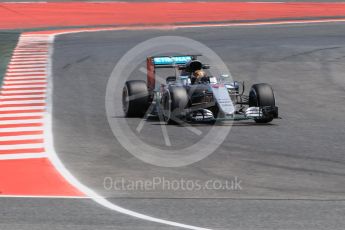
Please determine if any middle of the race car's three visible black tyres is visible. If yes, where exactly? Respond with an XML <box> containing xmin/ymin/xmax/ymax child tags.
<box><xmin>161</xmin><ymin>86</ymin><xmax>188</xmax><ymax>124</ymax></box>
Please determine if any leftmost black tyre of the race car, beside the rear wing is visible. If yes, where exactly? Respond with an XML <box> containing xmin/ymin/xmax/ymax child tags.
<box><xmin>122</xmin><ymin>80</ymin><xmax>149</xmax><ymax>117</ymax></box>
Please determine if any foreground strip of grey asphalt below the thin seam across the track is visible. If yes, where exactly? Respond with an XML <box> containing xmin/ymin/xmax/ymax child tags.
<box><xmin>0</xmin><ymin>198</ymin><xmax>345</xmax><ymax>230</ymax></box>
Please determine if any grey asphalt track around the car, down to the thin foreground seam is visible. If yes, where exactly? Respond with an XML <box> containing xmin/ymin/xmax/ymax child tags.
<box><xmin>53</xmin><ymin>24</ymin><xmax>345</xmax><ymax>199</ymax></box>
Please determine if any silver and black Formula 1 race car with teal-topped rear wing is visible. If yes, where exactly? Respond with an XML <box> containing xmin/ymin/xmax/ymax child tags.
<box><xmin>122</xmin><ymin>55</ymin><xmax>278</xmax><ymax>123</ymax></box>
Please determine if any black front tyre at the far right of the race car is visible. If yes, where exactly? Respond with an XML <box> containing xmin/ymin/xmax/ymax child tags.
<box><xmin>249</xmin><ymin>83</ymin><xmax>276</xmax><ymax>123</ymax></box>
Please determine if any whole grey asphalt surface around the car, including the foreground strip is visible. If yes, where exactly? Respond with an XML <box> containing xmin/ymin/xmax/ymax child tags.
<box><xmin>0</xmin><ymin>23</ymin><xmax>345</xmax><ymax>230</ymax></box>
